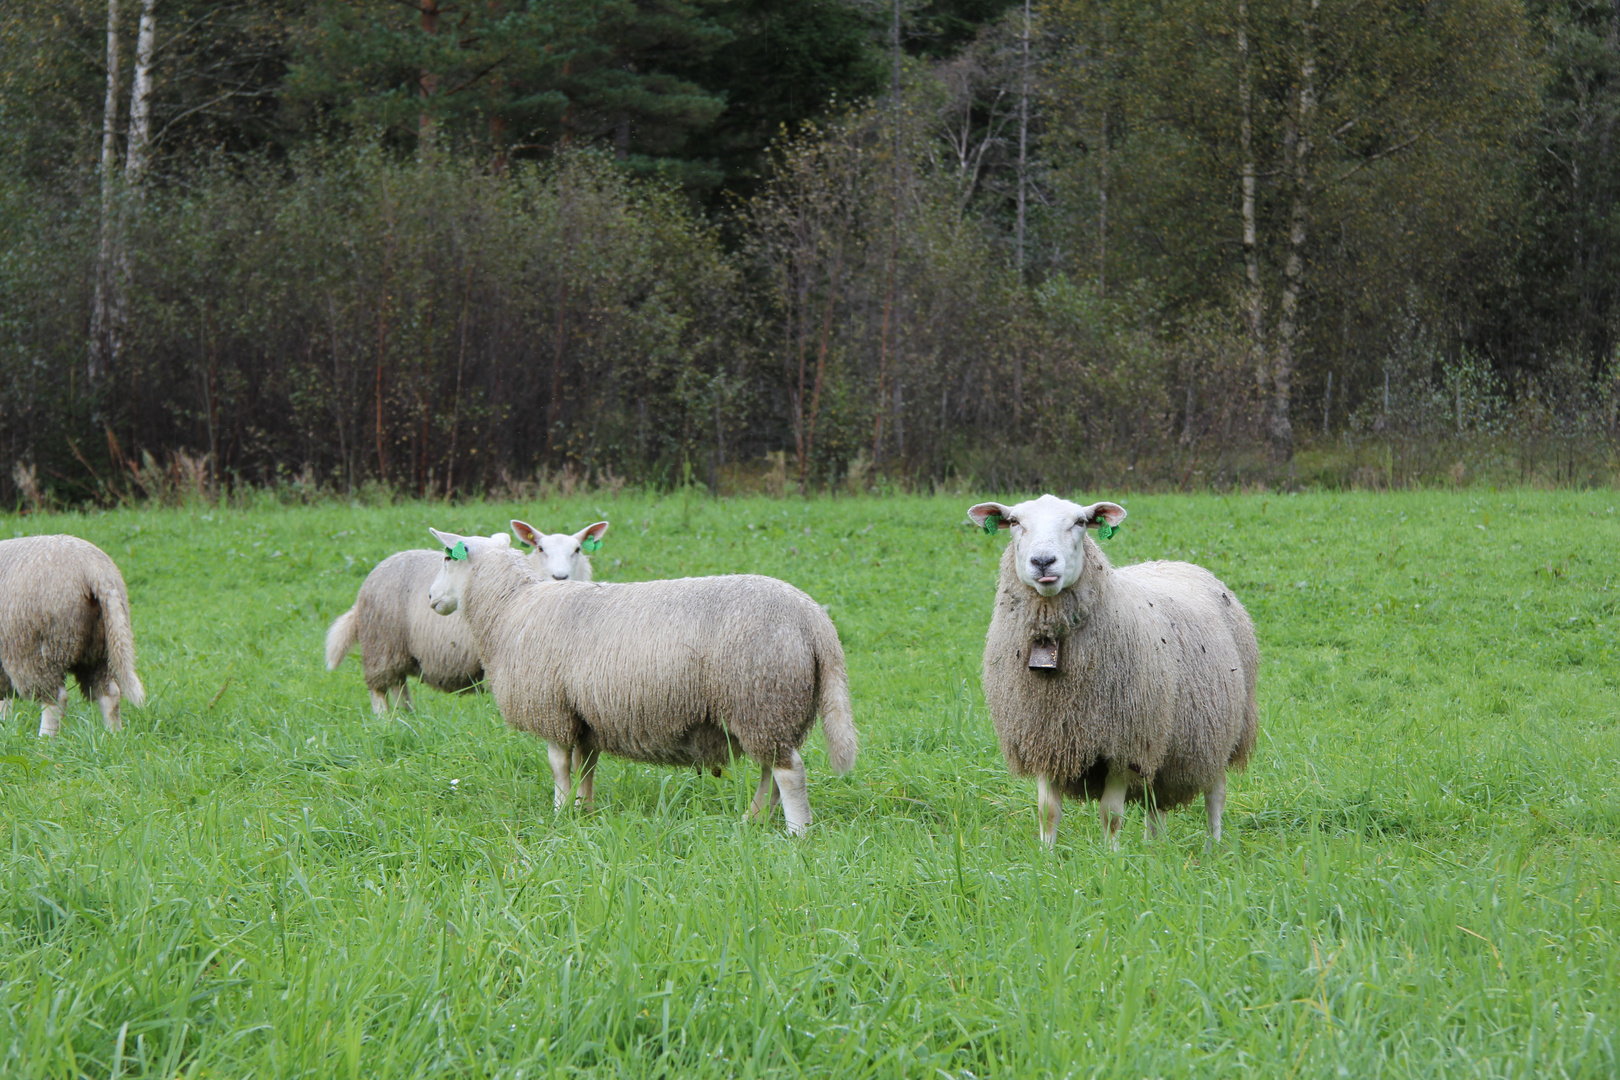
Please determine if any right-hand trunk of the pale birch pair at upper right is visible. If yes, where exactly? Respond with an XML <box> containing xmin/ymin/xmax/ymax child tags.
<box><xmin>1267</xmin><ymin>0</ymin><xmax>1320</xmax><ymax>461</ymax></box>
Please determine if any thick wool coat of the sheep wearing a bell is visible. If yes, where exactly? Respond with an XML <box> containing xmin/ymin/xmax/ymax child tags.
<box><xmin>983</xmin><ymin>534</ymin><xmax>1260</xmax><ymax>808</ymax></box>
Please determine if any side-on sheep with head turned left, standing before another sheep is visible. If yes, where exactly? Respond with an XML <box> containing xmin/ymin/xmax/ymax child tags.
<box><xmin>429</xmin><ymin>529</ymin><xmax>859</xmax><ymax>836</ymax></box>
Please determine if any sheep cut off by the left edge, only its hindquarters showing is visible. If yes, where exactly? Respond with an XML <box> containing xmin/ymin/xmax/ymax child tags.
<box><xmin>0</xmin><ymin>536</ymin><xmax>146</xmax><ymax>737</ymax></box>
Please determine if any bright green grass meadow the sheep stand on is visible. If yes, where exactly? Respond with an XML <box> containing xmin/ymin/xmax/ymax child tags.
<box><xmin>0</xmin><ymin>491</ymin><xmax>1620</xmax><ymax>1080</ymax></box>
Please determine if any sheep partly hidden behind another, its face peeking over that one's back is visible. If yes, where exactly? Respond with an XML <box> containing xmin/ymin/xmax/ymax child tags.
<box><xmin>326</xmin><ymin>521</ymin><xmax>608</xmax><ymax>714</ymax></box>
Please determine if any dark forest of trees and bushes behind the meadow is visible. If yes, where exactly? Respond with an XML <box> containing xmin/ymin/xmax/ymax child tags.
<box><xmin>0</xmin><ymin>0</ymin><xmax>1620</xmax><ymax>507</ymax></box>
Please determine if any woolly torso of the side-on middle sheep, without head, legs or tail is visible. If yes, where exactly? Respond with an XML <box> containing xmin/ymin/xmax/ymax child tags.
<box><xmin>488</xmin><ymin>575</ymin><xmax>836</xmax><ymax>764</ymax></box>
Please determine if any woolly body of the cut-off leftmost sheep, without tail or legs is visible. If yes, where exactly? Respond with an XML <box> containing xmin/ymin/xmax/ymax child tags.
<box><xmin>0</xmin><ymin>536</ymin><xmax>123</xmax><ymax>698</ymax></box>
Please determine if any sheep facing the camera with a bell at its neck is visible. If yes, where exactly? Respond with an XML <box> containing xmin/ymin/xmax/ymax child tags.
<box><xmin>967</xmin><ymin>495</ymin><xmax>1260</xmax><ymax>847</ymax></box>
